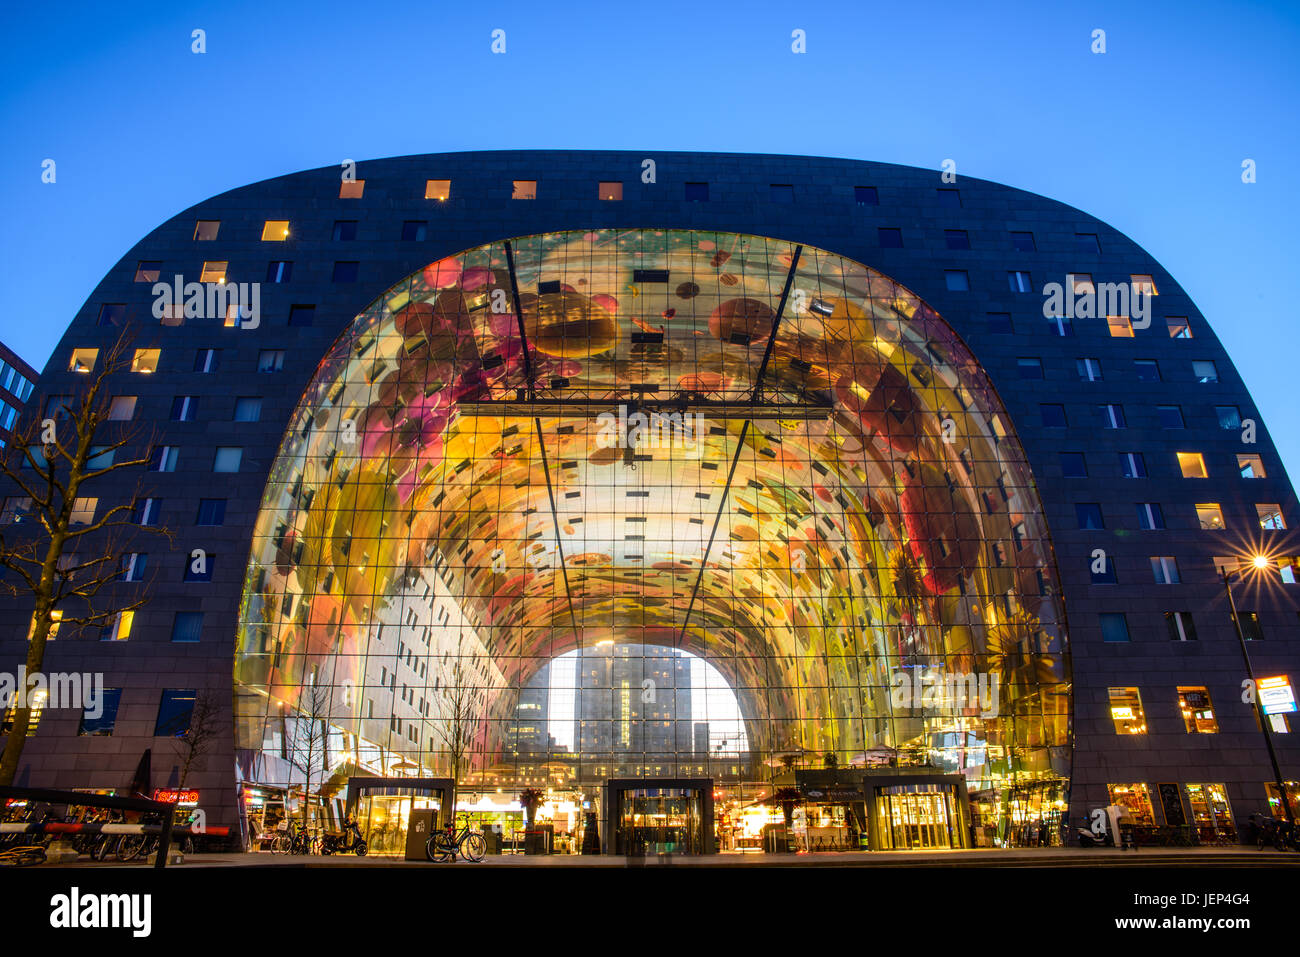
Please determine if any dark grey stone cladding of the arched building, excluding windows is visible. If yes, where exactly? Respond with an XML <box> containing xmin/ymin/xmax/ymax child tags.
<box><xmin>0</xmin><ymin>151</ymin><xmax>1300</xmax><ymax>837</ymax></box>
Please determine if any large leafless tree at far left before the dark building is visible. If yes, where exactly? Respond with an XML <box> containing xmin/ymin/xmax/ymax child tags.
<box><xmin>0</xmin><ymin>334</ymin><xmax>170</xmax><ymax>784</ymax></box>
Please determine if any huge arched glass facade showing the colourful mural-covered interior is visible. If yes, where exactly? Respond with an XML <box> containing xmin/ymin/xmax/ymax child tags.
<box><xmin>235</xmin><ymin>230</ymin><xmax>1071</xmax><ymax>848</ymax></box>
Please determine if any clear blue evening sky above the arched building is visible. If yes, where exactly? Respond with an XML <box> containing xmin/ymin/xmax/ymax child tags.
<box><xmin>0</xmin><ymin>0</ymin><xmax>1300</xmax><ymax>475</ymax></box>
